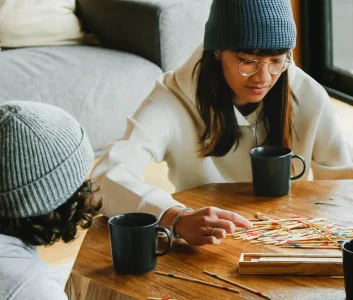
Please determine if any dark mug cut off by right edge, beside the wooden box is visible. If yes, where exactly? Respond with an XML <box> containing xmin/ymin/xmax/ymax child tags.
<box><xmin>342</xmin><ymin>240</ymin><xmax>353</xmax><ymax>300</ymax></box>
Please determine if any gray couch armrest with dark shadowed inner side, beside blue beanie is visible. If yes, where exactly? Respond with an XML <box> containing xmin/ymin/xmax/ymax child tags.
<box><xmin>77</xmin><ymin>0</ymin><xmax>212</xmax><ymax>71</ymax></box>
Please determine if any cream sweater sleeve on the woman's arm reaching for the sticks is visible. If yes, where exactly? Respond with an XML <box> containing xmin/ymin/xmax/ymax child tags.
<box><xmin>91</xmin><ymin>100</ymin><xmax>183</xmax><ymax>217</ymax></box>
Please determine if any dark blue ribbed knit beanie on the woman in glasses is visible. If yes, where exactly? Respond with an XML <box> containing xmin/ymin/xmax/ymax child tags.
<box><xmin>204</xmin><ymin>0</ymin><xmax>296</xmax><ymax>51</ymax></box>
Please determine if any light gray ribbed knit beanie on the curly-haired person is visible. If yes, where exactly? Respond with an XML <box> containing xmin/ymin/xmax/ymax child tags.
<box><xmin>0</xmin><ymin>101</ymin><xmax>93</xmax><ymax>218</ymax></box>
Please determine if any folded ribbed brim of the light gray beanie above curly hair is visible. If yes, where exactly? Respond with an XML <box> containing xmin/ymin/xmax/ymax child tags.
<box><xmin>0</xmin><ymin>134</ymin><xmax>94</xmax><ymax>218</ymax></box>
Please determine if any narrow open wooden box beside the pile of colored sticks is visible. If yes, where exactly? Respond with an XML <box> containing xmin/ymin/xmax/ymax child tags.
<box><xmin>239</xmin><ymin>253</ymin><xmax>343</xmax><ymax>276</ymax></box>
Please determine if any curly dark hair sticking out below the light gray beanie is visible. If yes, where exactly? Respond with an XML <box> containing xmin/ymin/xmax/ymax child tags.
<box><xmin>0</xmin><ymin>180</ymin><xmax>103</xmax><ymax>246</ymax></box>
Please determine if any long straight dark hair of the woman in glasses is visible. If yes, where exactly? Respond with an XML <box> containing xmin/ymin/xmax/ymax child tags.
<box><xmin>192</xmin><ymin>49</ymin><xmax>297</xmax><ymax>157</ymax></box>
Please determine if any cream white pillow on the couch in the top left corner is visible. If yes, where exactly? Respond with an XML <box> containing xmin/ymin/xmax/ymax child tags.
<box><xmin>0</xmin><ymin>0</ymin><xmax>84</xmax><ymax>48</ymax></box>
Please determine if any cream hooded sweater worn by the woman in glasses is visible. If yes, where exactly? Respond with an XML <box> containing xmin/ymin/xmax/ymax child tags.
<box><xmin>92</xmin><ymin>46</ymin><xmax>353</xmax><ymax>217</ymax></box>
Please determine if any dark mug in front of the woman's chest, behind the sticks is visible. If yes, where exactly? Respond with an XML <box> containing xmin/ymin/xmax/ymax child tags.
<box><xmin>250</xmin><ymin>146</ymin><xmax>306</xmax><ymax>197</ymax></box>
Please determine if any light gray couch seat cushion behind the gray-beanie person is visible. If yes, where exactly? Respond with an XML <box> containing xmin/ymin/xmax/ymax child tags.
<box><xmin>0</xmin><ymin>46</ymin><xmax>162</xmax><ymax>153</ymax></box>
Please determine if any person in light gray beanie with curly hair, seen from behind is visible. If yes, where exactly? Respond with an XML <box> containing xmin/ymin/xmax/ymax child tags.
<box><xmin>0</xmin><ymin>101</ymin><xmax>102</xmax><ymax>300</ymax></box>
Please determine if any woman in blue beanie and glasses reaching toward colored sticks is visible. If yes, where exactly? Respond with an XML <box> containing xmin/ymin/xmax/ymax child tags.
<box><xmin>93</xmin><ymin>0</ymin><xmax>353</xmax><ymax>245</ymax></box>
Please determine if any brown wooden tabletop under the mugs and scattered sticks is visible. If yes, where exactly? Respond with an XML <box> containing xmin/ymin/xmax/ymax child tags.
<box><xmin>66</xmin><ymin>180</ymin><xmax>353</xmax><ymax>300</ymax></box>
